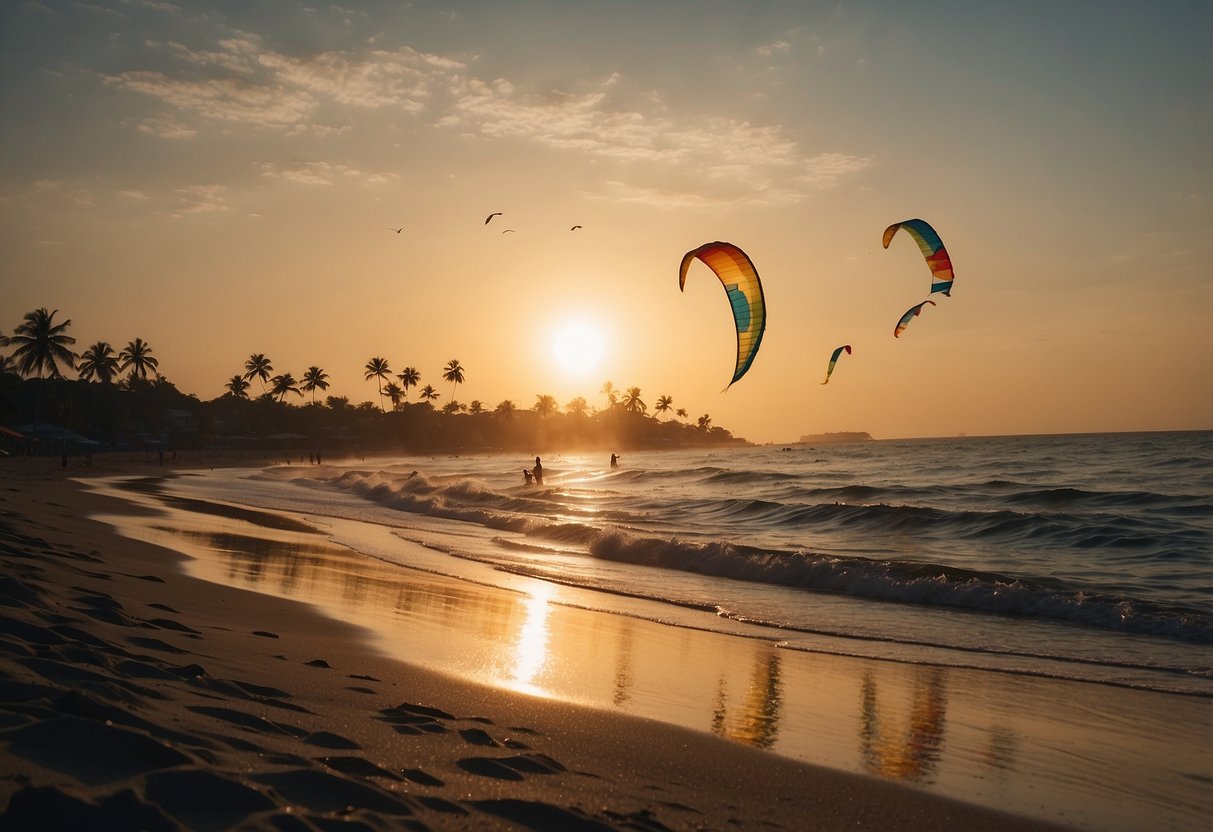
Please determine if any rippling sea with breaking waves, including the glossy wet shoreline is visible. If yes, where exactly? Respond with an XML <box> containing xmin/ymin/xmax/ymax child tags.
<box><xmin>87</xmin><ymin>432</ymin><xmax>1213</xmax><ymax>830</ymax></box>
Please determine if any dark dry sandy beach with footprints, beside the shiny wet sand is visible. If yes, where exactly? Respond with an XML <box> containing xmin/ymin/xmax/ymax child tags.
<box><xmin>0</xmin><ymin>458</ymin><xmax>1135</xmax><ymax>830</ymax></box>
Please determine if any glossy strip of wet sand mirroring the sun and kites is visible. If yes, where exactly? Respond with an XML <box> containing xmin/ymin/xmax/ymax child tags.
<box><xmin>89</xmin><ymin>483</ymin><xmax>1211</xmax><ymax>830</ymax></box>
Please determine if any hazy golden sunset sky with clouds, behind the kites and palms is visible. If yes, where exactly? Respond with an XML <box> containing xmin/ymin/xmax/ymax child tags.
<box><xmin>0</xmin><ymin>0</ymin><xmax>1213</xmax><ymax>443</ymax></box>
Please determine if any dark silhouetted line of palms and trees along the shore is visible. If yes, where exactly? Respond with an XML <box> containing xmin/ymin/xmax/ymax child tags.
<box><xmin>0</xmin><ymin>308</ymin><xmax>742</xmax><ymax>455</ymax></box>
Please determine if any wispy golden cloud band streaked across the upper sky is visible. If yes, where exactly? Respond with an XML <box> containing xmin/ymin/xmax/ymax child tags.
<box><xmin>106</xmin><ymin>32</ymin><xmax>873</xmax><ymax>205</ymax></box>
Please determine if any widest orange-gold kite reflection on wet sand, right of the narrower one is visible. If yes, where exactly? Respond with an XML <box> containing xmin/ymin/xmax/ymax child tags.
<box><xmin>859</xmin><ymin>667</ymin><xmax>946</xmax><ymax>782</ymax></box>
